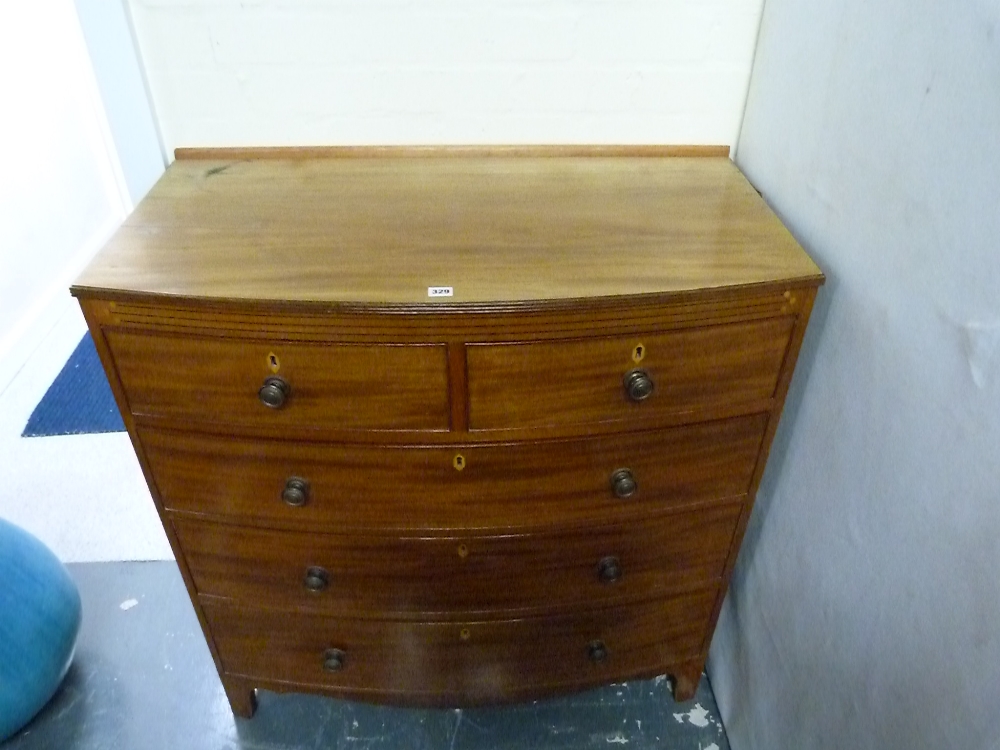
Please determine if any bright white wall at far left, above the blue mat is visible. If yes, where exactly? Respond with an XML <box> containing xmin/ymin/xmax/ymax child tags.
<box><xmin>0</xmin><ymin>0</ymin><xmax>128</xmax><ymax>391</ymax></box>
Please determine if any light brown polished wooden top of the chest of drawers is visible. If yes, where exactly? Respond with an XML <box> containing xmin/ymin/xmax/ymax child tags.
<box><xmin>73</xmin><ymin>152</ymin><xmax>822</xmax><ymax>306</ymax></box>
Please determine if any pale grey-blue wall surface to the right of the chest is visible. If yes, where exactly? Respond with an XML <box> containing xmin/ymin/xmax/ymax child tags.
<box><xmin>709</xmin><ymin>0</ymin><xmax>1000</xmax><ymax>750</ymax></box>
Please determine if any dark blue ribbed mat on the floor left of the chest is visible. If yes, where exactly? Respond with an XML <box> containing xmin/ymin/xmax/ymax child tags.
<box><xmin>21</xmin><ymin>332</ymin><xmax>125</xmax><ymax>437</ymax></box>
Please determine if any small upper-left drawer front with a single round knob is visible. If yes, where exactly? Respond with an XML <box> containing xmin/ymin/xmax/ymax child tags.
<box><xmin>106</xmin><ymin>330</ymin><xmax>449</xmax><ymax>435</ymax></box>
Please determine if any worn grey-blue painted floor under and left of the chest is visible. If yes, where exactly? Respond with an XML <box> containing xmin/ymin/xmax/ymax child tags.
<box><xmin>2</xmin><ymin>562</ymin><xmax>729</xmax><ymax>750</ymax></box>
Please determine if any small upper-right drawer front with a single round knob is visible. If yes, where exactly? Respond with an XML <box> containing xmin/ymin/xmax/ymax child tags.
<box><xmin>467</xmin><ymin>317</ymin><xmax>794</xmax><ymax>430</ymax></box>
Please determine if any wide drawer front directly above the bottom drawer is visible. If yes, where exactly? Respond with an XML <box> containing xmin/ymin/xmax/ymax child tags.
<box><xmin>173</xmin><ymin>502</ymin><xmax>742</xmax><ymax>614</ymax></box>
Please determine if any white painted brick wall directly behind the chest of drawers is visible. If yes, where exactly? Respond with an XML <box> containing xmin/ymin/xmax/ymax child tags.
<box><xmin>129</xmin><ymin>0</ymin><xmax>762</xmax><ymax>153</ymax></box>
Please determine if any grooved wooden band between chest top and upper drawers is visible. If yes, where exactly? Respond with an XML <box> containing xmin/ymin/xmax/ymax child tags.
<box><xmin>94</xmin><ymin>282</ymin><xmax>814</xmax><ymax>334</ymax></box>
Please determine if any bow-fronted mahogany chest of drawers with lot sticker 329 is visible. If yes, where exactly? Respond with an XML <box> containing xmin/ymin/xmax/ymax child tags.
<box><xmin>73</xmin><ymin>149</ymin><xmax>822</xmax><ymax>716</ymax></box>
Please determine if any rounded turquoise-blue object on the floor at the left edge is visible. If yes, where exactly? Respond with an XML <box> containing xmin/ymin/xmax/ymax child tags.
<box><xmin>0</xmin><ymin>519</ymin><xmax>81</xmax><ymax>742</ymax></box>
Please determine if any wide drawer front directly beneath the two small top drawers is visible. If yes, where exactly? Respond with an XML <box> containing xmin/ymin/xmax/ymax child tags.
<box><xmin>139</xmin><ymin>414</ymin><xmax>766</xmax><ymax>529</ymax></box>
